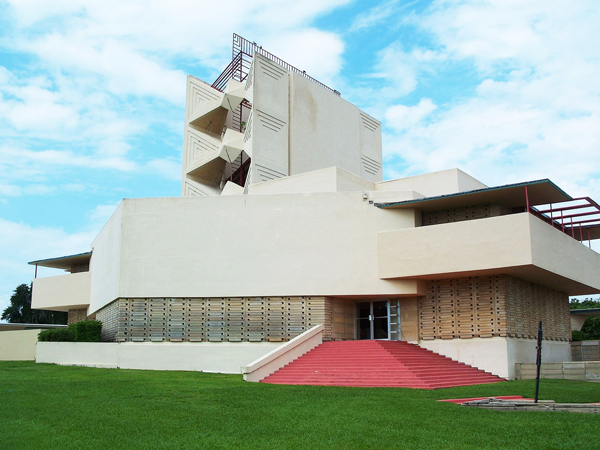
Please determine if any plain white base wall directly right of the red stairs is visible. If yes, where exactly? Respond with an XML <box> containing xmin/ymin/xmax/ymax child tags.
<box><xmin>419</xmin><ymin>337</ymin><xmax>571</xmax><ymax>379</ymax></box>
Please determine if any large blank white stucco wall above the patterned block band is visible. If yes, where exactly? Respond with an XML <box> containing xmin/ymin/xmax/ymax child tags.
<box><xmin>90</xmin><ymin>192</ymin><xmax>422</xmax><ymax>312</ymax></box>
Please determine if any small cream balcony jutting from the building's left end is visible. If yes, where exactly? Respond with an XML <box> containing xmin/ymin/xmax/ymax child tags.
<box><xmin>31</xmin><ymin>272</ymin><xmax>91</xmax><ymax>311</ymax></box>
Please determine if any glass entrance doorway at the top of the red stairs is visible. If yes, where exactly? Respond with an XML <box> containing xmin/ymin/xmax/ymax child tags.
<box><xmin>356</xmin><ymin>300</ymin><xmax>400</xmax><ymax>340</ymax></box>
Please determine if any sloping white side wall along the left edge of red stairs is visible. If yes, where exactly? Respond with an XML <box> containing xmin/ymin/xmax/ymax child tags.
<box><xmin>242</xmin><ymin>325</ymin><xmax>325</xmax><ymax>382</ymax></box>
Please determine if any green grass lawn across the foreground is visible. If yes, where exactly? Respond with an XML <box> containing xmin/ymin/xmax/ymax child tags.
<box><xmin>0</xmin><ymin>362</ymin><xmax>600</xmax><ymax>450</ymax></box>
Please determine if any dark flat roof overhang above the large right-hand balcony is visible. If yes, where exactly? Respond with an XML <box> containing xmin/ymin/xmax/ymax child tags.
<box><xmin>375</xmin><ymin>179</ymin><xmax>573</xmax><ymax>211</ymax></box>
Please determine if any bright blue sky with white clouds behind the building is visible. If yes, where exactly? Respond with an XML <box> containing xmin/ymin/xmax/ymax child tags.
<box><xmin>0</xmin><ymin>0</ymin><xmax>600</xmax><ymax>316</ymax></box>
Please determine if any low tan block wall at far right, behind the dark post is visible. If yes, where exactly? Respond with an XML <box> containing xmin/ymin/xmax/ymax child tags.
<box><xmin>515</xmin><ymin>361</ymin><xmax>600</xmax><ymax>381</ymax></box>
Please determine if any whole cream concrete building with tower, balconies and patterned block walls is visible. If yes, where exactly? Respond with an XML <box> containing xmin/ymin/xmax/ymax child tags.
<box><xmin>31</xmin><ymin>36</ymin><xmax>600</xmax><ymax>377</ymax></box>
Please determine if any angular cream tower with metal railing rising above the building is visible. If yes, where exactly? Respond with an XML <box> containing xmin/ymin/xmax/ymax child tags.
<box><xmin>181</xmin><ymin>34</ymin><xmax>382</xmax><ymax>196</ymax></box>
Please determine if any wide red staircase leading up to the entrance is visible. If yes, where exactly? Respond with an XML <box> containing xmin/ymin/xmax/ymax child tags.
<box><xmin>261</xmin><ymin>341</ymin><xmax>504</xmax><ymax>389</ymax></box>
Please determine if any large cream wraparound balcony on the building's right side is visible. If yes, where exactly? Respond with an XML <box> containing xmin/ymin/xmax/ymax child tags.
<box><xmin>378</xmin><ymin>212</ymin><xmax>600</xmax><ymax>295</ymax></box>
